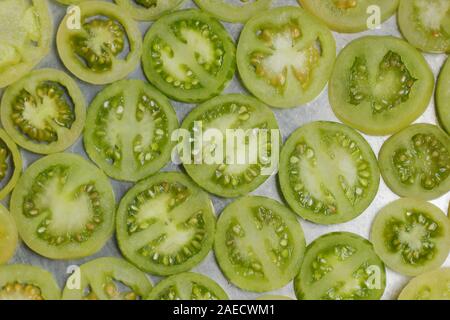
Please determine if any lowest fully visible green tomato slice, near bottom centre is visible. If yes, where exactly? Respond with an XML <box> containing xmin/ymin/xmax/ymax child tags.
<box><xmin>214</xmin><ymin>196</ymin><xmax>306</xmax><ymax>292</ymax></box>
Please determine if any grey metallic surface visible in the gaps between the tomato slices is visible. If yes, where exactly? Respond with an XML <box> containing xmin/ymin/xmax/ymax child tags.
<box><xmin>0</xmin><ymin>0</ymin><xmax>450</xmax><ymax>299</ymax></box>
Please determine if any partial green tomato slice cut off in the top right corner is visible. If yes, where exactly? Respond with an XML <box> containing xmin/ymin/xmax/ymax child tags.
<box><xmin>397</xmin><ymin>0</ymin><xmax>450</xmax><ymax>53</ymax></box>
